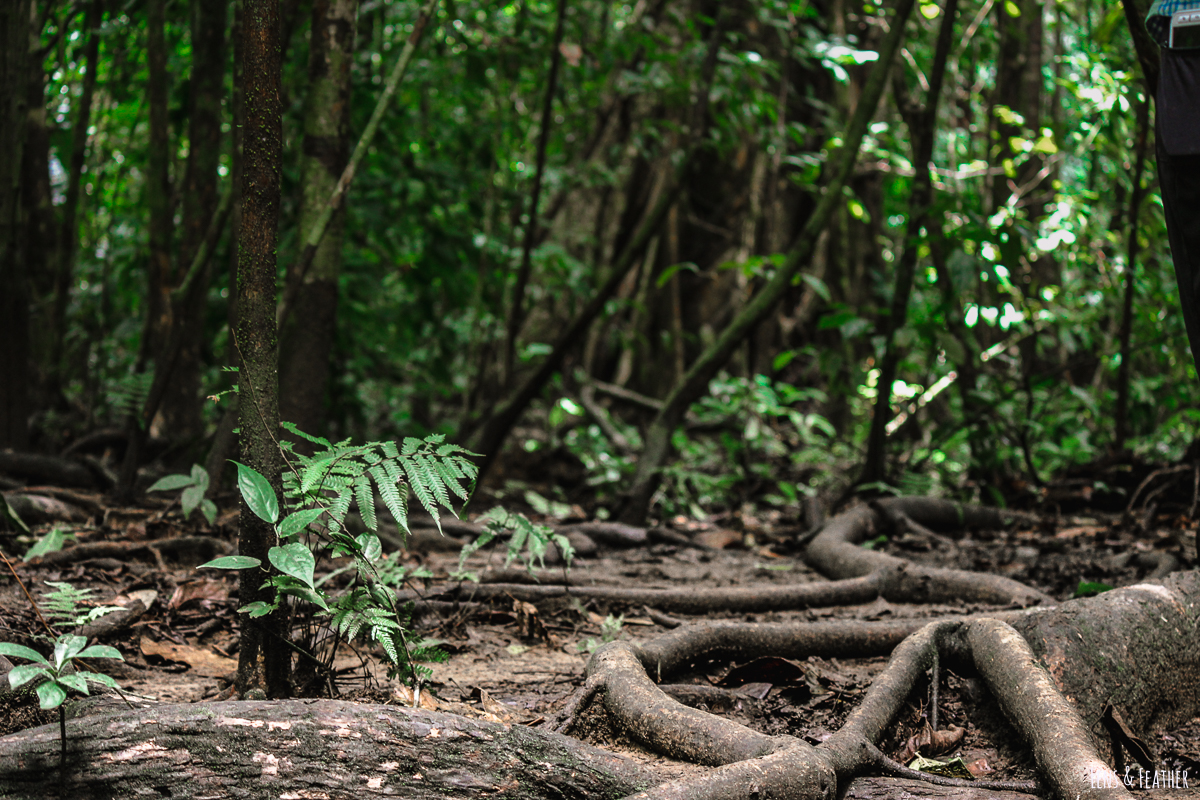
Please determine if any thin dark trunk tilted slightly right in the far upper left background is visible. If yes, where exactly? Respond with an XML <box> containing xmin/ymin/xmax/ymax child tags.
<box><xmin>49</xmin><ymin>0</ymin><xmax>104</xmax><ymax>392</ymax></box>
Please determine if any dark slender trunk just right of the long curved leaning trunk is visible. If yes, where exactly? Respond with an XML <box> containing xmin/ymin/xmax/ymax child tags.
<box><xmin>859</xmin><ymin>0</ymin><xmax>958</xmax><ymax>483</ymax></box>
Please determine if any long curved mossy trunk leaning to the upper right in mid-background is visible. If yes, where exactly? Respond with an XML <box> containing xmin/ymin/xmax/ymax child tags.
<box><xmin>620</xmin><ymin>0</ymin><xmax>913</xmax><ymax>523</ymax></box>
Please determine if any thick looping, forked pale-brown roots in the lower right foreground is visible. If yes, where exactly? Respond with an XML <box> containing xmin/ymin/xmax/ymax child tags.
<box><xmin>588</xmin><ymin>619</ymin><xmax>1129</xmax><ymax>800</ymax></box>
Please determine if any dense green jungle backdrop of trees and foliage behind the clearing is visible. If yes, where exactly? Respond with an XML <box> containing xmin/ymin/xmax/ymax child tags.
<box><xmin>0</xmin><ymin>0</ymin><xmax>1180</xmax><ymax>515</ymax></box>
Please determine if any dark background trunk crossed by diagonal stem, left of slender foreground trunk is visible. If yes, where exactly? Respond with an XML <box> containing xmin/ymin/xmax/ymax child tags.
<box><xmin>160</xmin><ymin>0</ymin><xmax>226</xmax><ymax>443</ymax></box>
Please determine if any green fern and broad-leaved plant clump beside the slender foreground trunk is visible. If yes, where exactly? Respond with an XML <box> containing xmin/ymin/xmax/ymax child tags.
<box><xmin>200</xmin><ymin>422</ymin><xmax>476</xmax><ymax>685</ymax></box>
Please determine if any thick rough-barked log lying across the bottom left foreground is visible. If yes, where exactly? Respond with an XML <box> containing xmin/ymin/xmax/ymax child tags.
<box><xmin>0</xmin><ymin>700</ymin><xmax>661</xmax><ymax>800</ymax></box>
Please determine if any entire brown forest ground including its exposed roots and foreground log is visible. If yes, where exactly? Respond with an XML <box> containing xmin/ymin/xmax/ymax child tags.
<box><xmin>0</xmin><ymin>467</ymin><xmax>1200</xmax><ymax>800</ymax></box>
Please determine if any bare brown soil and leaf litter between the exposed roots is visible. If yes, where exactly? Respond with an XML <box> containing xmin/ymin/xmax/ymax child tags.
<box><xmin>0</xmin><ymin>472</ymin><xmax>1200</xmax><ymax>796</ymax></box>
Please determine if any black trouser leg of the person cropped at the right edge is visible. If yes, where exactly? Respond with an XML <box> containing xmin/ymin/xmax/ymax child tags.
<box><xmin>1158</xmin><ymin>135</ymin><xmax>1200</xmax><ymax>373</ymax></box>
